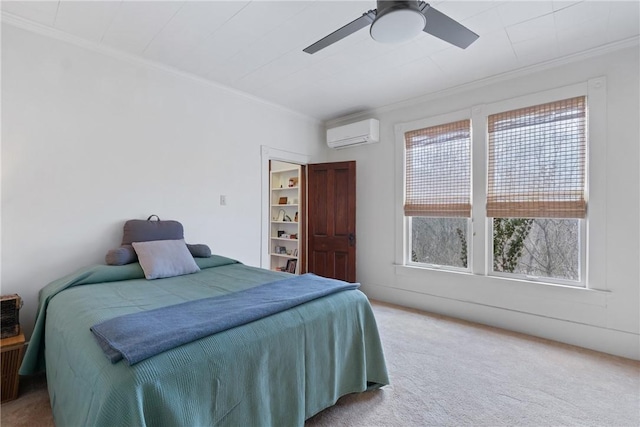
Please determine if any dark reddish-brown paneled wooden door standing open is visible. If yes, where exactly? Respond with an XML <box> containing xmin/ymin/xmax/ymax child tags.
<box><xmin>307</xmin><ymin>161</ymin><xmax>356</xmax><ymax>282</ymax></box>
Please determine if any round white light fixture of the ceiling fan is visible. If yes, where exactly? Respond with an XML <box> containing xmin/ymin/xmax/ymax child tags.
<box><xmin>370</xmin><ymin>8</ymin><xmax>427</xmax><ymax>43</ymax></box>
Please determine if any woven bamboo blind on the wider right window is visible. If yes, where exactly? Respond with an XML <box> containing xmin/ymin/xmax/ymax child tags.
<box><xmin>487</xmin><ymin>96</ymin><xmax>586</xmax><ymax>218</ymax></box>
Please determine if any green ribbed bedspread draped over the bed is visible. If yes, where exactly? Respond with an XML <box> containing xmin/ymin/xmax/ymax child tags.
<box><xmin>21</xmin><ymin>257</ymin><xmax>388</xmax><ymax>427</ymax></box>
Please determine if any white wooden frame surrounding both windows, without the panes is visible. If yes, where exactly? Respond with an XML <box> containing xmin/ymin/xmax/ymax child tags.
<box><xmin>395</xmin><ymin>77</ymin><xmax>608</xmax><ymax>291</ymax></box>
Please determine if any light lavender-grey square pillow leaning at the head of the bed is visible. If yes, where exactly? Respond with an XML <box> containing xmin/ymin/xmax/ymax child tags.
<box><xmin>131</xmin><ymin>239</ymin><xmax>200</xmax><ymax>280</ymax></box>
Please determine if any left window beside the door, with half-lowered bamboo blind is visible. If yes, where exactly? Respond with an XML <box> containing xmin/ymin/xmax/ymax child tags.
<box><xmin>404</xmin><ymin>119</ymin><xmax>471</xmax><ymax>269</ymax></box>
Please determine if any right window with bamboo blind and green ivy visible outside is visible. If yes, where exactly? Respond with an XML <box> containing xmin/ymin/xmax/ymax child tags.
<box><xmin>486</xmin><ymin>96</ymin><xmax>586</xmax><ymax>281</ymax></box>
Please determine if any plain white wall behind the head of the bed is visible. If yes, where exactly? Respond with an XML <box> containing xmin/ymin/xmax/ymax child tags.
<box><xmin>1</xmin><ymin>24</ymin><xmax>324</xmax><ymax>342</ymax></box>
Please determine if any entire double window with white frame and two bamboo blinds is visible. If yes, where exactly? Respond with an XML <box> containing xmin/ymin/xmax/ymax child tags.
<box><xmin>396</xmin><ymin>84</ymin><xmax>606</xmax><ymax>289</ymax></box>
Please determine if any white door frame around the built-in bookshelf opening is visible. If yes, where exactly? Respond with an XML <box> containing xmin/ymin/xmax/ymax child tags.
<box><xmin>260</xmin><ymin>145</ymin><xmax>311</xmax><ymax>269</ymax></box>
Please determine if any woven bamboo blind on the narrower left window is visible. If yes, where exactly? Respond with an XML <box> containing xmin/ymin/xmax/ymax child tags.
<box><xmin>404</xmin><ymin>120</ymin><xmax>471</xmax><ymax>217</ymax></box>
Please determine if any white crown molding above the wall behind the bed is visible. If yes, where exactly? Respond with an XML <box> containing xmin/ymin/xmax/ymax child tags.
<box><xmin>0</xmin><ymin>11</ymin><xmax>322</xmax><ymax>125</ymax></box>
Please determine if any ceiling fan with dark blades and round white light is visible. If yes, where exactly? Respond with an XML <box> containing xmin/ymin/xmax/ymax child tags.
<box><xmin>303</xmin><ymin>0</ymin><xmax>478</xmax><ymax>54</ymax></box>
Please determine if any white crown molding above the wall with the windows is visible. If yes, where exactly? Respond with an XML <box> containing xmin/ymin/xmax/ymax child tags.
<box><xmin>325</xmin><ymin>36</ymin><xmax>640</xmax><ymax>126</ymax></box>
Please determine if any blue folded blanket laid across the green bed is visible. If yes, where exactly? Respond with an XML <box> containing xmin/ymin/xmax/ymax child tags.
<box><xmin>91</xmin><ymin>273</ymin><xmax>360</xmax><ymax>365</ymax></box>
